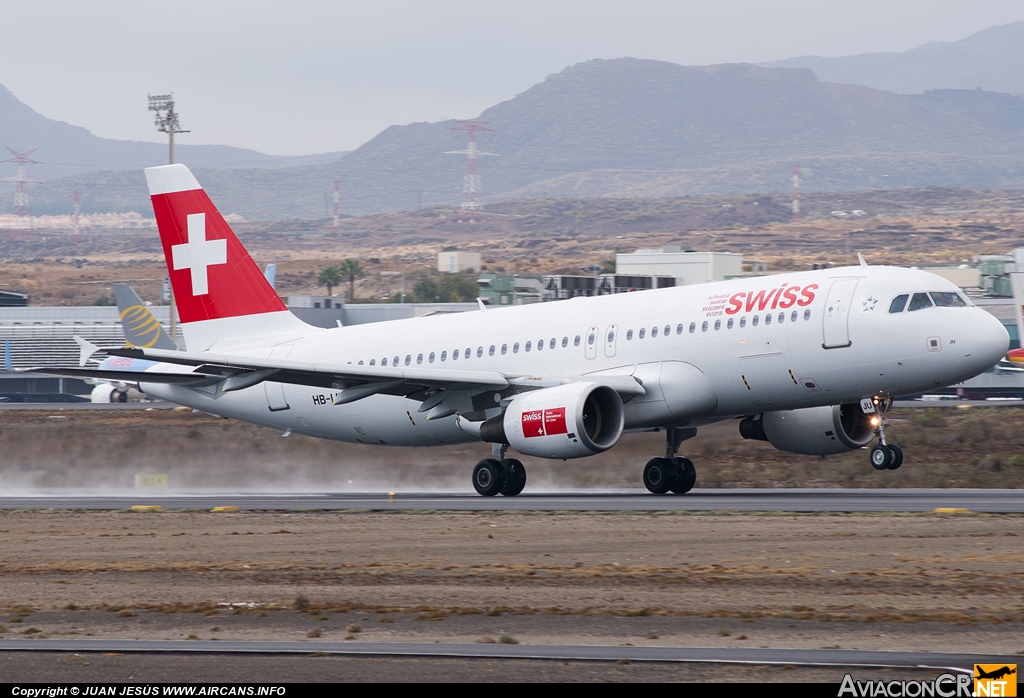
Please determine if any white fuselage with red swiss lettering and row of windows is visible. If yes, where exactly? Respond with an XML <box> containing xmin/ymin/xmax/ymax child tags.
<box><xmin>140</xmin><ymin>267</ymin><xmax>1009</xmax><ymax>446</ymax></box>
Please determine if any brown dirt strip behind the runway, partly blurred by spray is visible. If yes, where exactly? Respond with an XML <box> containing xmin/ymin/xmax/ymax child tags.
<box><xmin>0</xmin><ymin>406</ymin><xmax>1024</xmax><ymax>494</ymax></box>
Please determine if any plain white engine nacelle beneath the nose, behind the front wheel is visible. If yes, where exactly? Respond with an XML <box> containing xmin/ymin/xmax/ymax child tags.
<box><xmin>739</xmin><ymin>404</ymin><xmax>876</xmax><ymax>455</ymax></box>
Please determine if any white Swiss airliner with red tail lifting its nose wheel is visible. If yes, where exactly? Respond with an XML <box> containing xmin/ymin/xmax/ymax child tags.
<box><xmin>37</xmin><ymin>165</ymin><xmax>1010</xmax><ymax>496</ymax></box>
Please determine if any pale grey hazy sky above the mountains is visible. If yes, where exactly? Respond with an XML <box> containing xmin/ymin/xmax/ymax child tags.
<box><xmin>0</xmin><ymin>0</ymin><xmax>1024</xmax><ymax>155</ymax></box>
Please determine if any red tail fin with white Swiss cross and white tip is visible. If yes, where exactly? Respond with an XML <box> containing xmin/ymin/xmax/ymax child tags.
<box><xmin>145</xmin><ymin>165</ymin><xmax>309</xmax><ymax>351</ymax></box>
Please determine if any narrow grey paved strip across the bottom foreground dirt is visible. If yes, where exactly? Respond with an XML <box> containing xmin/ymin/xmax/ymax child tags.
<box><xmin>0</xmin><ymin>640</ymin><xmax>1020</xmax><ymax>673</ymax></box>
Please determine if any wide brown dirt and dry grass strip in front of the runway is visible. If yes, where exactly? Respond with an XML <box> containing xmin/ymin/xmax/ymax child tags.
<box><xmin>0</xmin><ymin>512</ymin><xmax>1024</xmax><ymax>654</ymax></box>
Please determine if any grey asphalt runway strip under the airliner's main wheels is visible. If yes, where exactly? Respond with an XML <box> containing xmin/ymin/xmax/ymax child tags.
<box><xmin>0</xmin><ymin>488</ymin><xmax>1024</xmax><ymax>514</ymax></box>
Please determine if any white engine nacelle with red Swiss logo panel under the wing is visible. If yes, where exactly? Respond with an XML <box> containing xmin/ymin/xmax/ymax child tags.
<box><xmin>480</xmin><ymin>383</ymin><xmax>626</xmax><ymax>459</ymax></box>
